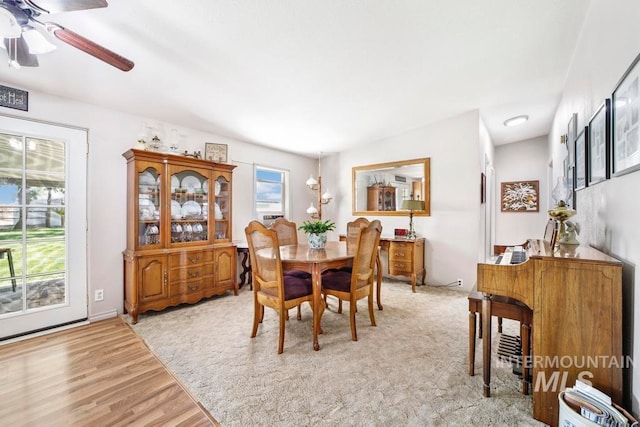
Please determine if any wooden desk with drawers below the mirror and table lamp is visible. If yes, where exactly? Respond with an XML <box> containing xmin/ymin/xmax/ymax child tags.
<box><xmin>380</xmin><ymin>236</ymin><xmax>427</xmax><ymax>292</ymax></box>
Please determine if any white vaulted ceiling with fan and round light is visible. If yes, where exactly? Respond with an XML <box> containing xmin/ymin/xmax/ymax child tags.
<box><xmin>0</xmin><ymin>0</ymin><xmax>590</xmax><ymax>156</ymax></box>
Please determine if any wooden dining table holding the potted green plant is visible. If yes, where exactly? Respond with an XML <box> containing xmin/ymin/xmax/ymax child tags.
<box><xmin>278</xmin><ymin>242</ymin><xmax>355</xmax><ymax>350</ymax></box>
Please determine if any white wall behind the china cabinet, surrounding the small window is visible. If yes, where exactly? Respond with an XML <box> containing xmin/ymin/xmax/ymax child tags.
<box><xmin>3</xmin><ymin>88</ymin><xmax>317</xmax><ymax>319</ymax></box>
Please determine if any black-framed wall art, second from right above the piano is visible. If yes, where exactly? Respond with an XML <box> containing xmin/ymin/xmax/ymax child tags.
<box><xmin>587</xmin><ymin>99</ymin><xmax>611</xmax><ymax>185</ymax></box>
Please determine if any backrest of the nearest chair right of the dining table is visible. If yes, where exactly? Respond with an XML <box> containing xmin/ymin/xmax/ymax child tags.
<box><xmin>351</xmin><ymin>219</ymin><xmax>382</xmax><ymax>292</ymax></box>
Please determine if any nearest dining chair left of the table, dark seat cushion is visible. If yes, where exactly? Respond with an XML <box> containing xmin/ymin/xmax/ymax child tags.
<box><xmin>244</xmin><ymin>221</ymin><xmax>313</xmax><ymax>354</ymax></box>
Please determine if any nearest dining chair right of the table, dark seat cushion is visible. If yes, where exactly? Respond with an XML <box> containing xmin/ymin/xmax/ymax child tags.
<box><xmin>322</xmin><ymin>220</ymin><xmax>382</xmax><ymax>341</ymax></box>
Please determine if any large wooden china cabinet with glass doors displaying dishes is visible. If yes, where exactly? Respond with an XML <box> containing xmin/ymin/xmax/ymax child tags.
<box><xmin>123</xmin><ymin>149</ymin><xmax>238</xmax><ymax>323</ymax></box>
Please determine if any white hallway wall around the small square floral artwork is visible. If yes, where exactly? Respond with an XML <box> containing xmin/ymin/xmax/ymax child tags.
<box><xmin>495</xmin><ymin>136</ymin><xmax>549</xmax><ymax>245</ymax></box>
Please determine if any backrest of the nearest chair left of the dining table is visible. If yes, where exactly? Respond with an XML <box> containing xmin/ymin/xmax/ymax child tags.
<box><xmin>244</xmin><ymin>221</ymin><xmax>284</xmax><ymax>300</ymax></box>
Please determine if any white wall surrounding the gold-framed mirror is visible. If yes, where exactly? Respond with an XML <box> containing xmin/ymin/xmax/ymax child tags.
<box><xmin>323</xmin><ymin>111</ymin><xmax>481</xmax><ymax>289</ymax></box>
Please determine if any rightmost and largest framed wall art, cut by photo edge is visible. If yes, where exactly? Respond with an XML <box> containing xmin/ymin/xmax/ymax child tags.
<box><xmin>611</xmin><ymin>51</ymin><xmax>640</xmax><ymax>176</ymax></box>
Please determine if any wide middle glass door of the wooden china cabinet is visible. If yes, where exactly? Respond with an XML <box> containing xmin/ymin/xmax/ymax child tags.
<box><xmin>167</xmin><ymin>165</ymin><xmax>212</xmax><ymax>246</ymax></box>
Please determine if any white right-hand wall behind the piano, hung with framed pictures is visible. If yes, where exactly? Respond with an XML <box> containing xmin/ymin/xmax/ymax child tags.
<box><xmin>548</xmin><ymin>0</ymin><xmax>640</xmax><ymax>415</ymax></box>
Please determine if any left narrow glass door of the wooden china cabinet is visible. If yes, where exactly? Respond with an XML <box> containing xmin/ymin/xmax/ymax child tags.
<box><xmin>132</xmin><ymin>162</ymin><xmax>164</xmax><ymax>249</ymax></box>
